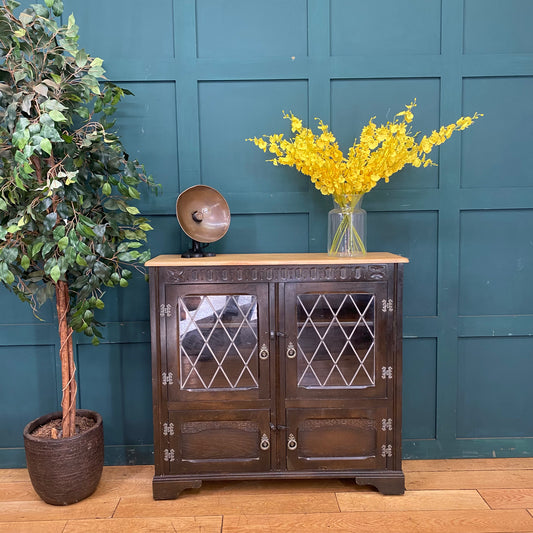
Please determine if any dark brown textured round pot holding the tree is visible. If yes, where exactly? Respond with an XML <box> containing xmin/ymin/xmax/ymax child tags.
<box><xmin>24</xmin><ymin>409</ymin><xmax>104</xmax><ymax>505</ymax></box>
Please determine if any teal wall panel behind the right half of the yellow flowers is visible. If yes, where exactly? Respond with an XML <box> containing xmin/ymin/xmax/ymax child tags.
<box><xmin>330</xmin><ymin>78</ymin><xmax>440</xmax><ymax>189</ymax></box>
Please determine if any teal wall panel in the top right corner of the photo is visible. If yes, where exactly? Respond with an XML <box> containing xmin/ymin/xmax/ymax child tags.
<box><xmin>464</xmin><ymin>0</ymin><xmax>533</xmax><ymax>54</ymax></box>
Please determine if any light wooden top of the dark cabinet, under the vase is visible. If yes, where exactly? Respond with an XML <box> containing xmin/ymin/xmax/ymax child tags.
<box><xmin>146</xmin><ymin>252</ymin><xmax>409</xmax><ymax>267</ymax></box>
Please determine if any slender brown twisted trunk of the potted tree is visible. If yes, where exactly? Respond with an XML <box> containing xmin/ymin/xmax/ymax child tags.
<box><xmin>56</xmin><ymin>281</ymin><xmax>77</xmax><ymax>437</ymax></box>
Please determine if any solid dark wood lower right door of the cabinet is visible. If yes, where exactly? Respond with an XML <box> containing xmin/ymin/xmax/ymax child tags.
<box><xmin>286</xmin><ymin>407</ymin><xmax>392</xmax><ymax>470</ymax></box>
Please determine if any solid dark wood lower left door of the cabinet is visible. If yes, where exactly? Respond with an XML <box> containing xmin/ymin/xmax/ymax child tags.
<box><xmin>164</xmin><ymin>409</ymin><xmax>271</xmax><ymax>474</ymax></box>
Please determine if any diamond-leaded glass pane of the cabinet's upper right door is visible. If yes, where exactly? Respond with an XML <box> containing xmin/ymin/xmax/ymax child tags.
<box><xmin>297</xmin><ymin>293</ymin><xmax>375</xmax><ymax>389</ymax></box>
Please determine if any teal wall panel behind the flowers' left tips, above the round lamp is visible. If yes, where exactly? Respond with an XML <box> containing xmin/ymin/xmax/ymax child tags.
<box><xmin>198</xmin><ymin>80</ymin><xmax>309</xmax><ymax>195</ymax></box>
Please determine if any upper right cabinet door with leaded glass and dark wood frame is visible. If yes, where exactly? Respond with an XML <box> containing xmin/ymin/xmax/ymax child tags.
<box><xmin>280</xmin><ymin>281</ymin><xmax>391</xmax><ymax>399</ymax></box>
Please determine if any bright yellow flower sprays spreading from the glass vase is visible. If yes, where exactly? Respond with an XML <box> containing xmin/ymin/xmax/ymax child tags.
<box><xmin>246</xmin><ymin>99</ymin><xmax>483</xmax><ymax>253</ymax></box>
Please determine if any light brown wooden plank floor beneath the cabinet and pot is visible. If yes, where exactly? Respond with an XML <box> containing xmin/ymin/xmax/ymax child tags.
<box><xmin>0</xmin><ymin>458</ymin><xmax>533</xmax><ymax>533</ymax></box>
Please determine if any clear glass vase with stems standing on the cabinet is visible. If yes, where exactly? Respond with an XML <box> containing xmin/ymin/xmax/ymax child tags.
<box><xmin>328</xmin><ymin>194</ymin><xmax>366</xmax><ymax>257</ymax></box>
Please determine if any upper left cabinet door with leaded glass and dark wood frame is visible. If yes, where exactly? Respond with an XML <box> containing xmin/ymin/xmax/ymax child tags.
<box><xmin>165</xmin><ymin>283</ymin><xmax>270</xmax><ymax>401</ymax></box>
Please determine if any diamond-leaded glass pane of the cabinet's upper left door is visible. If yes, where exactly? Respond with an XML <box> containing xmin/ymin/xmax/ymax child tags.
<box><xmin>178</xmin><ymin>294</ymin><xmax>259</xmax><ymax>390</ymax></box>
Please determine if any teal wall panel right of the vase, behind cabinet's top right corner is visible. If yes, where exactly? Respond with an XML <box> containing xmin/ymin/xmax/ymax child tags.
<box><xmin>363</xmin><ymin>209</ymin><xmax>438</xmax><ymax>316</ymax></box>
